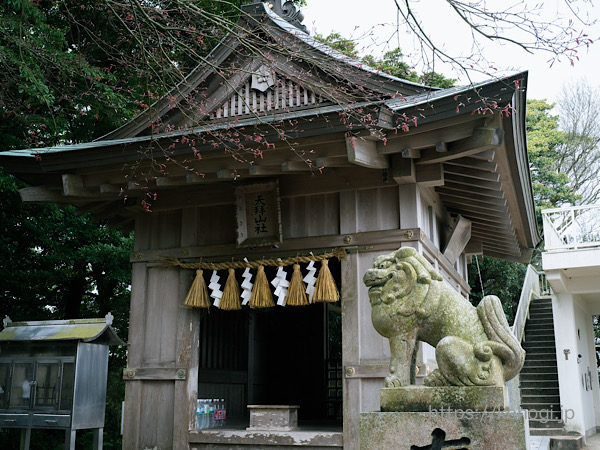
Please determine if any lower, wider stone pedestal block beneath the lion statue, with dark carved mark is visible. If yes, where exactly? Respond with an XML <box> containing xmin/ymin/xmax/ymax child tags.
<box><xmin>360</xmin><ymin>407</ymin><xmax>529</xmax><ymax>450</ymax></box>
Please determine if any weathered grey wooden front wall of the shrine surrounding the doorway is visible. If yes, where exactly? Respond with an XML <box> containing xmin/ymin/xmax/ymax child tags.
<box><xmin>124</xmin><ymin>178</ymin><xmax>468</xmax><ymax>449</ymax></box>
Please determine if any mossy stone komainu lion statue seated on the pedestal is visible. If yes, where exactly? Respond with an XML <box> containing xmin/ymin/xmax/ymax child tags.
<box><xmin>364</xmin><ymin>247</ymin><xmax>525</xmax><ymax>387</ymax></box>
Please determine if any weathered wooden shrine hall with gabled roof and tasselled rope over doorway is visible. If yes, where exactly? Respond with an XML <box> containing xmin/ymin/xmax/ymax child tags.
<box><xmin>0</xmin><ymin>1</ymin><xmax>540</xmax><ymax>450</ymax></box>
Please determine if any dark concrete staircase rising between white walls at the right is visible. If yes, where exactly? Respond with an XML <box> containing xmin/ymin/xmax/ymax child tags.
<box><xmin>520</xmin><ymin>297</ymin><xmax>564</xmax><ymax>436</ymax></box>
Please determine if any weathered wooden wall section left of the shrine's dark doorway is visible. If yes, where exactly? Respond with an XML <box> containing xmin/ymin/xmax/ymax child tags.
<box><xmin>123</xmin><ymin>211</ymin><xmax>199</xmax><ymax>450</ymax></box>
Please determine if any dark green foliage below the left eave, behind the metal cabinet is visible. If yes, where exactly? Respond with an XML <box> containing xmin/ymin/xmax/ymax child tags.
<box><xmin>0</xmin><ymin>169</ymin><xmax>132</xmax><ymax>449</ymax></box>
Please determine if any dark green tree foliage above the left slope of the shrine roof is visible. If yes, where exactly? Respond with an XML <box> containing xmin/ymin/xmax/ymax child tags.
<box><xmin>0</xmin><ymin>0</ymin><xmax>134</xmax><ymax>150</ymax></box>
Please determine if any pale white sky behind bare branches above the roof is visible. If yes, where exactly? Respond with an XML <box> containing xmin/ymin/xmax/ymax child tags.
<box><xmin>302</xmin><ymin>0</ymin><xmax>600</xmax><ymax>102</ymax></box>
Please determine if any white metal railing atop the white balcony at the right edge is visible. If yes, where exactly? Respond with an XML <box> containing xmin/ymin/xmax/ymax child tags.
<box><xmin>542</xmin><ymin>205</ymin><xmax>600</xmax><ymax>251</ymax></box>
